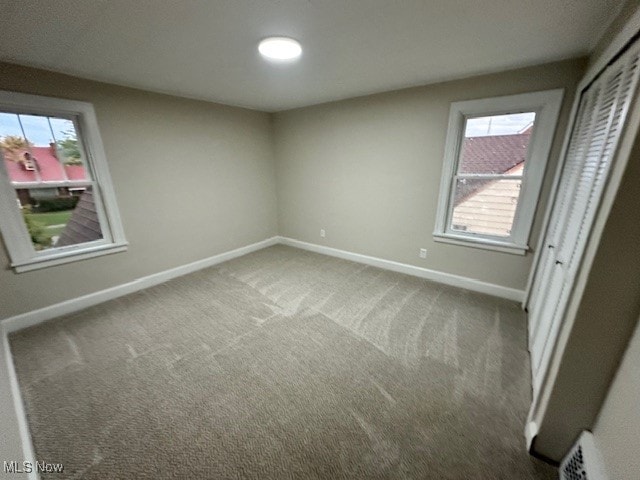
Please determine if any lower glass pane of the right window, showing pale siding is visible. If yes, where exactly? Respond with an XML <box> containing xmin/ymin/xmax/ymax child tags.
<box><xmin>451</xmin><ymin>178</ymin><xmax>522</xmax><ymax>237</ymax></box>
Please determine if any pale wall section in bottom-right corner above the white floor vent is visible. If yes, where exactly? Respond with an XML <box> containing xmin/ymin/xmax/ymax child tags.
<box><xmin>593</xmin><ymin>322</ymin><xmax>640</xmax><ymax>480</ymax></box>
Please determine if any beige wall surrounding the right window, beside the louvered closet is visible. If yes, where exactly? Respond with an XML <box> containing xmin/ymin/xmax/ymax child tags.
<box><xmin>275</xmin><ymin>56</ymin><xmax>585</xmax><ymax>289</ymax></box>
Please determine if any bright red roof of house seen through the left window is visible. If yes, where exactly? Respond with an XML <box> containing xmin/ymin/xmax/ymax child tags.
<box><xmin>4</xmin><ymin>147</ymin><xmax>87</xmax><ymax>183</ymax></box>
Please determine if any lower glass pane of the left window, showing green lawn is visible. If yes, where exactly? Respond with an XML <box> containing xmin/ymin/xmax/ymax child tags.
<box><xmin>16</xmin><ymin>187</ymin><xmax>102</xmax><ymax>250</ymax></box>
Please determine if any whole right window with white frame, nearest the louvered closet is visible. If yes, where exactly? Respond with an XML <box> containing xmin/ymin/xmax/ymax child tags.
<box><xmin>434</xmin><ymin>90</ymin><xmax>563</xmax><ymax>255</ymax></box>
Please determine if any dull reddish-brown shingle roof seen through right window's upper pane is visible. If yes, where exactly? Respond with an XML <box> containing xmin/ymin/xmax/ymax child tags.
<box><xmin>460</xmin><ymin>128</ymin><xmax>531</xmax><ymax>173</ymax></box>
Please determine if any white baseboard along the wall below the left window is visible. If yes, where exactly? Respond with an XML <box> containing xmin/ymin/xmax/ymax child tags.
<box><xmin>0</xmin><ymin>237</ymin><xmax>279</xmax><ymax>333</ymax></box>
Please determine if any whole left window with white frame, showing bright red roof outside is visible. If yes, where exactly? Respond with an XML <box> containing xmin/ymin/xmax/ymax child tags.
<box><xmin>0</xmin><ymin>92</ymin><xmax>127</xmax><ymax>272</ymax></box>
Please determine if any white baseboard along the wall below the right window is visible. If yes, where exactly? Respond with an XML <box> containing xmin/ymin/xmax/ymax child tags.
<box><xmin>279</xmin><ymin>237</ymin><xmax>524</xmax><ymax>302</ymax></box>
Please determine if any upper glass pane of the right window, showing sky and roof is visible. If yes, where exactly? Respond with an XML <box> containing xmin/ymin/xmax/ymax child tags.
<box><xmin>458</xmin><ymin>112</ymin><xmax>536</xmax><ymax>175</ymax></box>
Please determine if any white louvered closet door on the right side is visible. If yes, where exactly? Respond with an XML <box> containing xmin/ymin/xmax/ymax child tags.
<box><xmin>529</xmin><ymin>44</ymin><xmax>640</xmax><ymax>392</ymax></box>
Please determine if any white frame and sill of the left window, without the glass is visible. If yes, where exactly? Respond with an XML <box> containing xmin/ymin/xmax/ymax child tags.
<box><xmin>0</xmin><ymin>91</ymin><xmax>128</xmax><ymax>273</ymax></box>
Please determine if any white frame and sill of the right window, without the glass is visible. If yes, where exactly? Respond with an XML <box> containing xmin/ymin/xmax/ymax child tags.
<box><xmin>433</xmin><ymin>89</ymin><xmax>564</xmax><ymax>255</ymax></box>
